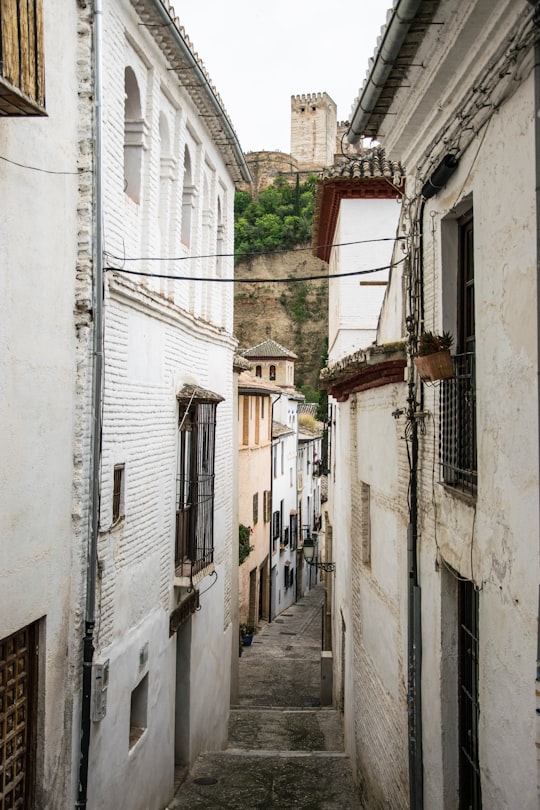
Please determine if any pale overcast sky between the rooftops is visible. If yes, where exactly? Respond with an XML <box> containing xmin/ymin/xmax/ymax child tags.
<box><xmin>174</xmin><ymin>0</ymin><xmax>392</xmax><ymax>152</ymax></box>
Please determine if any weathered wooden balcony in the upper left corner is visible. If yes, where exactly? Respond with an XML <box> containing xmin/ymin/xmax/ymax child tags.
<box><xmin>0</xmin><ymin>0</ymin><xmax>46</xmax><ymax>116</ymax></box>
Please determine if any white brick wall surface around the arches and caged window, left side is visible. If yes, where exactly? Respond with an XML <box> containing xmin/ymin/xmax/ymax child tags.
<box><xmin>85</xmin><ymin>3</ymin><xmax>238</xmax><ymax>810</ymax></box>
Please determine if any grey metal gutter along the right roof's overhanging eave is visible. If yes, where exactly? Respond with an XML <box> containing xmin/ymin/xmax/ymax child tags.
<box><xmin>347</xmin><ymin>0</ymin><xmax>422</xmax><ymax>143</ymax></box>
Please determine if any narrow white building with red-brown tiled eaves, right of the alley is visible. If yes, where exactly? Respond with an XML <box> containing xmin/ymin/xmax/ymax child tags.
<box><xmin>314</xmin><ymin>148</ymin><xmax>407</xmax><ymax>807</ymax></box>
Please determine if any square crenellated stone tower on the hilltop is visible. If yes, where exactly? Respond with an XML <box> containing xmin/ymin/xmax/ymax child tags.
<box><xmin>291</xmin><ymin>93</ymin><xmax>337</xmax><ymax>169</ymax></box>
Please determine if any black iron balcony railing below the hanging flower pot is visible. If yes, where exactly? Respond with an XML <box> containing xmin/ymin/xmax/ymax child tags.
<box><xmin>439</xmin><ymin>353</ymin><xmax>478</xmax><ymax>495</ymax></box>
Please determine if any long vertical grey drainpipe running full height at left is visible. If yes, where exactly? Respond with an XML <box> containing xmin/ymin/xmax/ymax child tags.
<box><xmin>75</xmin><ymin>0</ymin><xmax>103</xmax><ymax>810</ymax></box>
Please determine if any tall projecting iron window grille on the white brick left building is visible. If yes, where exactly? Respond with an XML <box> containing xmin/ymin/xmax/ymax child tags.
<box><xmin>175</xmin><ymin>401</ymin><xmax>217</xmax><ymax>576</ymax></box>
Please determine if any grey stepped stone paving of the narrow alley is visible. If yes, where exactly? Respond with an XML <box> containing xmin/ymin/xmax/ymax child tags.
<box><xmin>169</xmin><ymin>585</ymin><xmax>364</xmax><ymax>810</ymax></box>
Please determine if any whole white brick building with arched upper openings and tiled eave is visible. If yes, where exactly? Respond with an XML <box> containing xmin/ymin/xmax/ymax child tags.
<box><xmin>88</xmin><ymin>0</ymin><xmax>249</xmax><ymax>810</ymax></box>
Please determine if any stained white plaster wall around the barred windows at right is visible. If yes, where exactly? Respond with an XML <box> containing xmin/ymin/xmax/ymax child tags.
<box><xmin>416</xmin><ymin>71</ymin><xmax>538</xmax><ymax>808</ymax></box>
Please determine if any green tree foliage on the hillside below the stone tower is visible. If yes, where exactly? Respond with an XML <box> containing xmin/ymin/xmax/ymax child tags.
<box><xmin>234</xmin><ymin>175</ymin><xmax>317</xmax><ymax>258</ymax></box>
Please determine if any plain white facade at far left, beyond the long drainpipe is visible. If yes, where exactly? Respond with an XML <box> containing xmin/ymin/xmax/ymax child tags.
<box><xmin>0</xmin><ymin>0</ymin><xmax>91</xmax><ymax>810</ymax></box>
